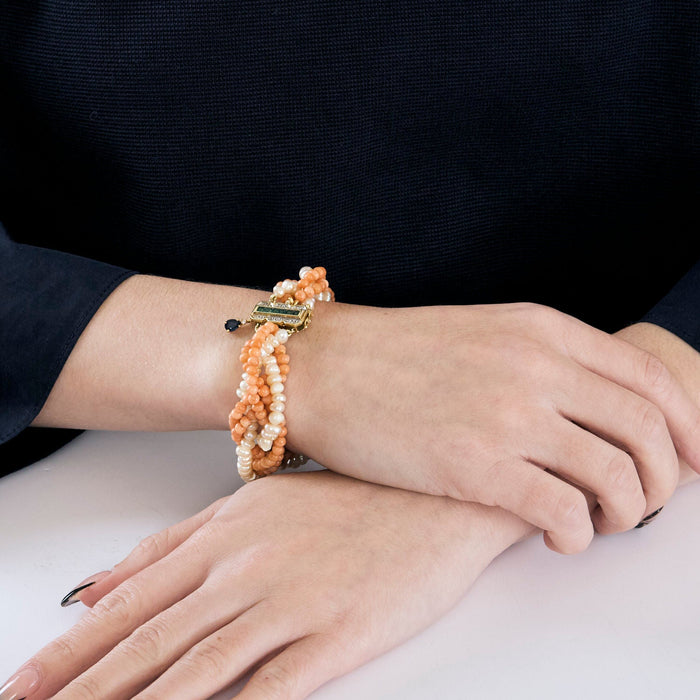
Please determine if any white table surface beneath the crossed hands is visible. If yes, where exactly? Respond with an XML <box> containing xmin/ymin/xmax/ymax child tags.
<box><xmin>0</xmin><ymin>432</ymin><xmax>700</xmax><ymax>700</ymax></box>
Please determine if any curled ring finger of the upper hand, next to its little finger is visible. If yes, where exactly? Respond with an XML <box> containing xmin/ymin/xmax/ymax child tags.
<box><xmin>528</xmin><ymin>417</ymin><xmax>647</xmax><ymax>534</ymax></box>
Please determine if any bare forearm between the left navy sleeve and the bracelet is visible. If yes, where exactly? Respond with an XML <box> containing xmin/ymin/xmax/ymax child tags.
<box><xmin>33</xmin><ymin>275</ymin><xmax>300</xmax><ymax>438</ymax></box>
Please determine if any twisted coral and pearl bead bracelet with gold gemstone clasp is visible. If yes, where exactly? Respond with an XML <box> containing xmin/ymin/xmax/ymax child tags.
<box><xmin>224</xmin><ymin>267</ymin><xmax>335</xmax><ymax>481</ymax></box>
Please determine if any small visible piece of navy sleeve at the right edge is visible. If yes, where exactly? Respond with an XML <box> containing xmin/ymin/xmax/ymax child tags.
<box><xmin>641</xmin><ymin>260</ymin><xmax>700</xmax><ymax>352</ymax></box>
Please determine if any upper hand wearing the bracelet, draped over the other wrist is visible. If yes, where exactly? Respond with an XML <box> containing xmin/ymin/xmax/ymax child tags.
<box><xmin>286</xmin><ymin>304</ymin><xmax>700</xmax><ymax>553</ymax></box>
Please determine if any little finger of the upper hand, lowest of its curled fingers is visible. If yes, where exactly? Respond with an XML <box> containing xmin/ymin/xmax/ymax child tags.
<box><xmin>474</xmin><ymin>458</ymin><xmax>593</xmax><ymax>554</ymax></box>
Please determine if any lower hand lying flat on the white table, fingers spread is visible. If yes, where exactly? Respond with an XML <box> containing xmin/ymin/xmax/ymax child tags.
<box><xmin>0</xmin><ymin>472</ymin><xmax>528</xmax><ymax>700</ymax></box>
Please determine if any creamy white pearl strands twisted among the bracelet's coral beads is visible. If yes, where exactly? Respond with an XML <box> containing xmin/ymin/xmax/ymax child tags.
<box><xmin>236</xmin><ymin>266</ymin><xmax>331</xmax><ymax>481</ymax></box>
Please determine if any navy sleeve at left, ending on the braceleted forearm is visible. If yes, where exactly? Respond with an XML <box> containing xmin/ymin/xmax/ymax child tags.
<box><xmin>0</xmin><ymin>225</ymin><xmax>135</xmax><ymax>475</ymax></box>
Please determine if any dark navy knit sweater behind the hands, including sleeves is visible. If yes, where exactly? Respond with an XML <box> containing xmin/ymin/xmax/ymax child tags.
<box><xmin>0</xmin><ymin>0</ymin><xmax>700</xmax><ymax>473</ymax></box>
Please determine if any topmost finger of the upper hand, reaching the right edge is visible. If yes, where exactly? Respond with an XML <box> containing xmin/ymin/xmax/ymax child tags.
<box><xmin>566</xmin><ymin>317</ymin><xmax>700</xmax><ymax>473</ymax></box>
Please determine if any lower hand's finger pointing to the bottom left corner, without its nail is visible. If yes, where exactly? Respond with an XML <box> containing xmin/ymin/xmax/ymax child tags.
<box><xmin>17</xmin><ymin>550</ymin><xmax>206</xmax><ymax>700</ymax></box>
